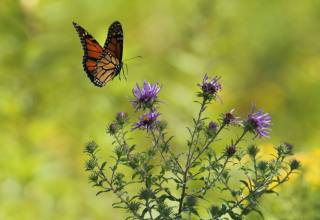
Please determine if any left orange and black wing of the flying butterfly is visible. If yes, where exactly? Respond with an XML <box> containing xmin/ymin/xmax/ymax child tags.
<box><xmin>73</xmin><ymin>22</ymin><xmax>103</xmax><ymax>87</ymax></box>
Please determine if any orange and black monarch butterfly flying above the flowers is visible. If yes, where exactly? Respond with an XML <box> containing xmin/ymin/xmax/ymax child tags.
<box><xmin>73</xmin><ymin>21</ymin><xmax>123</xmax><ymax>87</ymax></box>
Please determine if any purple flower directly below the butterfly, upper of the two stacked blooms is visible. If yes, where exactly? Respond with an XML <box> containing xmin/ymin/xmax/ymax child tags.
<box><xmin>132</xmin><ymin>81</ymin><xmax>160</xmax><ymax>110</ymax></box>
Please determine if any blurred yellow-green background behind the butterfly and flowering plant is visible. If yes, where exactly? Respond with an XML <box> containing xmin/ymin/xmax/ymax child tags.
<box><xmin>0</xmin><ymin>0</ymin><xmax>320</xmax><ymax>220</ymax></box>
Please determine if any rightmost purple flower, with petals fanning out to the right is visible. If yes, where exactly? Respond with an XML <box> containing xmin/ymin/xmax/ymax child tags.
<box><xmin>245</xmin><ymin>107</ymin><xmax>271</xmax><ymax>138</ymax></box>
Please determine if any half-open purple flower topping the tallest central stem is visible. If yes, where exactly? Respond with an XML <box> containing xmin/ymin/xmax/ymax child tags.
<box><xmin>198</xmin><ymin>74</ymin><xmax>222</xmax><ymax>99</ymax></box>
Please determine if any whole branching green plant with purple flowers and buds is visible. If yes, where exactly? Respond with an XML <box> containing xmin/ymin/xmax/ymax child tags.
<box><xmin>85</xmin><ymin>74</ymin><xmax>301</xmax><ymax>220</ymax></box>
